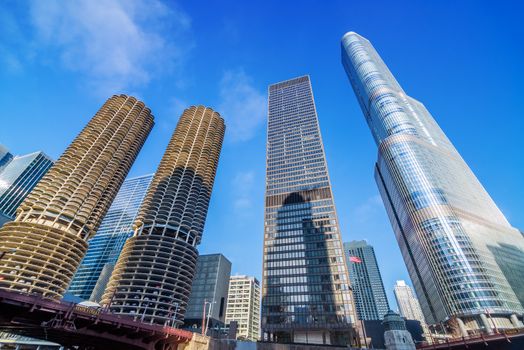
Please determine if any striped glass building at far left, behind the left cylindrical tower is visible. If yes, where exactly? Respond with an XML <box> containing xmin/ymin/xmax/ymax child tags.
<box><xmin>0</xmin><ymin>149</ymin><xmax>53</xmax><ymax>221</ymax></box>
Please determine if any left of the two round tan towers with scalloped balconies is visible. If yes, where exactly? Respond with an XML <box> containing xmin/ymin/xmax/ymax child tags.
<box><xmin>0</xmin><ymin>95</ymin><xmax>153</xmax><ymax>298</ymax></box>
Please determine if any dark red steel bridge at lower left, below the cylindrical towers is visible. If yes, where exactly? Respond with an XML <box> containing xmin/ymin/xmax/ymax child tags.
<box><xmin>0</xmin><ymin>290</ymin><xmax>194</xmax><ymax>350</ymax></box>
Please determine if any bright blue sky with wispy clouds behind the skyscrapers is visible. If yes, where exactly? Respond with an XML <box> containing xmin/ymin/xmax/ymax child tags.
<box><xmin>0</xmin><ymin>0</ymin><xmax>524</xmax><ymax>304</ymax></box>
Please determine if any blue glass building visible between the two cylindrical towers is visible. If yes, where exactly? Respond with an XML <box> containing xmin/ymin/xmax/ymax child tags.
<box><xmin>68</xmin><ymin>174</ymin><xmax>153</xmax><ymax>302</ymax></box>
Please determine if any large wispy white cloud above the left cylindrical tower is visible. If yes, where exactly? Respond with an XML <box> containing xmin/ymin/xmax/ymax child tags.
<box><xmin>26</xmin><ymin>0</ymin><xmax>191</xmax><ymax>95</ymax></box>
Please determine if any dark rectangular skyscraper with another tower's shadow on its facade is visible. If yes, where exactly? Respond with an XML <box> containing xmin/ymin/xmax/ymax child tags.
<box><xmin>262</xmin><ymin>76</ymin><xmax>358</xmax><ymax>345</ymax></box>
